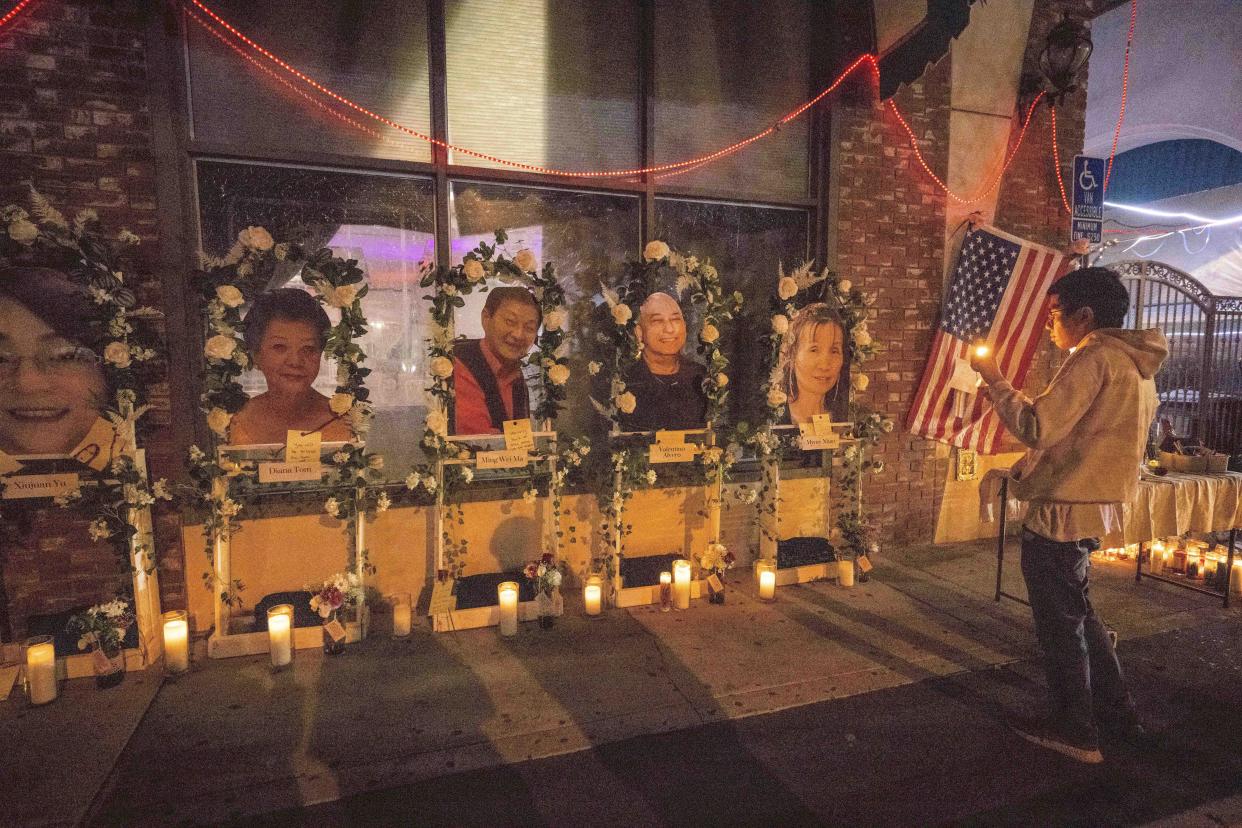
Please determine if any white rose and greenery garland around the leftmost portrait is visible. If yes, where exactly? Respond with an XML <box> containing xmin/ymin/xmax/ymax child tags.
<box><xmin>0</xmin><ymin>190</ymin><xmax>171</xmax><ymax>571</ymax></box>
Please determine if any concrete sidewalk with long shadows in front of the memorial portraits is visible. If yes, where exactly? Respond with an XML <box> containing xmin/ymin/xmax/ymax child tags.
<box><xmin>0</xmin><ymin>544</ymin><xmax>1242</xmax><ymax>824</ymax></box>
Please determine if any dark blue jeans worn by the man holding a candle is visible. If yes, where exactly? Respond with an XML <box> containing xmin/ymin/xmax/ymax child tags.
<box><xmin>1022</xmin><ymin>529</ymin><xmax>1134</xmax><ymax>736</ymax></box>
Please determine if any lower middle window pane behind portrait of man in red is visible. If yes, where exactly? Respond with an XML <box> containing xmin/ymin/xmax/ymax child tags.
<box><xmin>450</xmin><ymin>181</ymin><xmax>640</xmax><ymax>434</ymax></box>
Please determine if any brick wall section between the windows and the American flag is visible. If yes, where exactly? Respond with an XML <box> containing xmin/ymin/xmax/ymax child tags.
<box><xmin>830</xmin><ymin>57</ymin><xmax>949</xmax><ymax>541</ymax></box>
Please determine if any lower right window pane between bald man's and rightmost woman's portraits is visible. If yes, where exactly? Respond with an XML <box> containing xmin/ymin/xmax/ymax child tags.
<box><xmin>656</xmin><ymin>199</ymin><xmax>810</xmax><ymax>422</ymax></box>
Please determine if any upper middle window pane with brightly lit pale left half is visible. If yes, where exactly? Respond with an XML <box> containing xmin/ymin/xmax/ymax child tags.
<box><xmin>445</xmin><ymin>0</ymin><xmax>638</xmax><ymax>169</ymax></box>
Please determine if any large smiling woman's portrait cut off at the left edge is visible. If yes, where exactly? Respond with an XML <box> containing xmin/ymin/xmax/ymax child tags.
<box><xmin>0</xmin><ymin>267</ymin><xmax>107</xmax><ymax>459</ymax></box>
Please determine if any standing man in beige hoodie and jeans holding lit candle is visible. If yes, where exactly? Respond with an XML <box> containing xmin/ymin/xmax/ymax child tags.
<box><xmin>971</xmin><ymin>267</ymin><xmax>1169</xmax><ymax>762</ymax></box>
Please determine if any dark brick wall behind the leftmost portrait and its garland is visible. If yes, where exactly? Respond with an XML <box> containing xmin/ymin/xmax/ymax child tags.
<box><xmin>0</xmin><ymin>0</ymin><xmax>185</xmax><ymax>637</ymax></box>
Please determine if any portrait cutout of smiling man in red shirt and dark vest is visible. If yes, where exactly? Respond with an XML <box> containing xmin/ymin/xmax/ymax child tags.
<box><xmin>452</xmin><ymin>286</ymin><xmax>543</xmax><ymax>434</ymax></box>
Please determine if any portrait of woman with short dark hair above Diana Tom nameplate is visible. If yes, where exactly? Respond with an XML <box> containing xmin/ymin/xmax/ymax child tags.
<box><xmin>230</xmin><ymin>288</ymin><xmax>353</xmax><ymax>444</ymax></box>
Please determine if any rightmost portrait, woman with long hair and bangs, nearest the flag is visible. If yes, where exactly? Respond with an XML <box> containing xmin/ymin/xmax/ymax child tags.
<box><xmin>779</xmin><ymin>302</ymin><xmax>850</xmax><ymax>426</ymax></box>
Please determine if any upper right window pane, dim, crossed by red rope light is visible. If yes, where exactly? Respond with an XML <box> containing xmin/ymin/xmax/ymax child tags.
<box><xmin>656</xmin><ymin>0</ymin><xmax>811</xmax><ymax>197</ymax></box>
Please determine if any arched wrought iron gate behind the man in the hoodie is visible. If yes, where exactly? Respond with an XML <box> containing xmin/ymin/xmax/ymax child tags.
<box><xmin>1108</xmin><ymin>261</ymin><xmax>1242</xmax><ymax>468</ymax></box>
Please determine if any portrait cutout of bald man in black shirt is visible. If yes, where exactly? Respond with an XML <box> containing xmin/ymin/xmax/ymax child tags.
<box><xmin>621</xmin><ymin>293</ymin><xmax>707</xmax><ymax>431</ymax></box>
